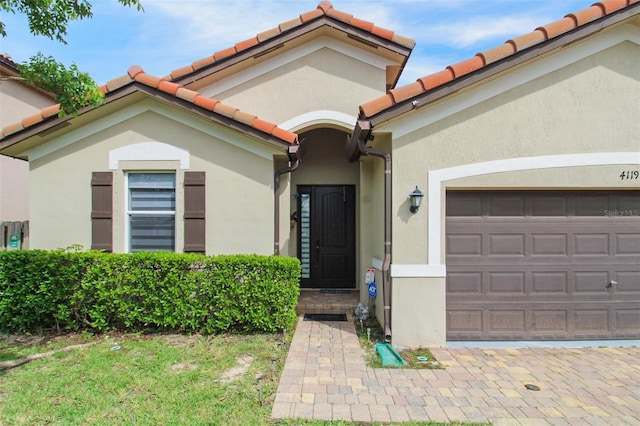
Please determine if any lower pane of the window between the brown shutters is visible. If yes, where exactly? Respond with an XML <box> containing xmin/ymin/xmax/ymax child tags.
<box><xmin>129</xmin><ymin>215</ymin><xmax>176</xmax><ymax>252</ymax></box>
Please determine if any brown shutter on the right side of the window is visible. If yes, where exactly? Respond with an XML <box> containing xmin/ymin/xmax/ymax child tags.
<box><xmin>184</xmin><ymin>172</ymin><xmax>206</xmax><ymax>254</ymax></box>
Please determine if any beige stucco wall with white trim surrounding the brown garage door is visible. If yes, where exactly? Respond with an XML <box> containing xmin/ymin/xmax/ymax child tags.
<box><xmin>387</xmin><ymin>35</ymin><xmax>640</xmax><ymax>346</ymax></box>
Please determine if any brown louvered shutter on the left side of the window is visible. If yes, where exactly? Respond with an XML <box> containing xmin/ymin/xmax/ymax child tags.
<box><xmin>91</xmin><ymin>172</ymin><xmax>113</xmax><ymax>252</ymax></box>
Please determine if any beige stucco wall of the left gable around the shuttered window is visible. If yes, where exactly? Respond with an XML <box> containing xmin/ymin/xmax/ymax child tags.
<box><xmin>30</xmin><ymin>101</ymin><xmax>276</xmax><ymax>254</ymax></box>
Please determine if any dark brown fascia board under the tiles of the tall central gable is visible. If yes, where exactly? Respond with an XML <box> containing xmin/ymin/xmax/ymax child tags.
<box><xmin>172</xmin><ymin>15</ymin><xmax>411</xmax><ymax>86</ymax></box>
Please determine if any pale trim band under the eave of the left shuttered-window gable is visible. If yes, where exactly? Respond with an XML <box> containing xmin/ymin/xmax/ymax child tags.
<box><xmin>20</xmin><ymin>99</ymin><xmax>282</xmax><ymax>161</ymax></box>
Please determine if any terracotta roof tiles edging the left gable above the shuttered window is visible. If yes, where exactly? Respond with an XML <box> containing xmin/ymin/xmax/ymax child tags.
<box><xmin>0</xmin><ymin>66</ymin><xmax>298</xmax><ymax>144</ymax></box>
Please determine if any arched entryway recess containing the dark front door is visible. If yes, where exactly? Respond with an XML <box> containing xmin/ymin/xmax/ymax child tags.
<box><xmin>289</xmin><ymin>128</ymin><xmax>358</xmax><ymax>289</ymax></box>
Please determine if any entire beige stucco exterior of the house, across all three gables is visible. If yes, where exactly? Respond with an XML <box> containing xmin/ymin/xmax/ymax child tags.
<box><xmin>0</xmin><ymin>5</ymin><xmax>640</xmax><ymax>347</ymax></box>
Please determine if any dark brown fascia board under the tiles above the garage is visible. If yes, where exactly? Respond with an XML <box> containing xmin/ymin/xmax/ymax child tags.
<box><xmin>369</xmin><ymin>3</ymin><xmax>640</xmax><ymax>127</ymax></box>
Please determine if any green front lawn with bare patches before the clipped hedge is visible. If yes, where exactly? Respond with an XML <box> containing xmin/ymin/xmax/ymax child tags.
<box><xmin>0</xmin><ymin>334</ymin><xmax>480</xmax><ymax>426</ymax></box>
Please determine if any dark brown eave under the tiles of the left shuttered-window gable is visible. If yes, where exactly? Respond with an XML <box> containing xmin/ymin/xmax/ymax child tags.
<box><xmin>0</xmin><ymin>82</ymin><xmax>295</xmax><ymax>158</ymax></box>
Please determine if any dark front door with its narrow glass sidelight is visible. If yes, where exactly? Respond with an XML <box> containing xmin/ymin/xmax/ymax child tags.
<box><xmin>298</xmin><ymin>185</ymin><xmax>355</xmax><ymax>288</ymax></box>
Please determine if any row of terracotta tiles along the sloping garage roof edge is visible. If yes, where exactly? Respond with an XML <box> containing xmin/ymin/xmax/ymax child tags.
<box><xmin>360</xmin><ymin>0</ymin><xmax>640</xmax><ymax>119</ymax></box>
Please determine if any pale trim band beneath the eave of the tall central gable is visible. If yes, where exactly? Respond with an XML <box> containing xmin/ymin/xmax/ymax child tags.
<box><xmin>200</xmin><ymin>36</ymin><xmax>401</xmax><ymax>97</ymax></box>
